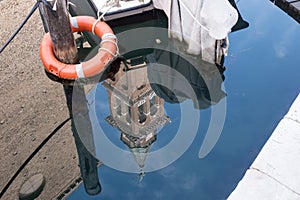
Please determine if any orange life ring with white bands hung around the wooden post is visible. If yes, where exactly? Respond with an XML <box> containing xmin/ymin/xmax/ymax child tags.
<box><xmin>40</xmin><ymin>16</ymin><xmax>118</xmax><ymax>80</ymax></box>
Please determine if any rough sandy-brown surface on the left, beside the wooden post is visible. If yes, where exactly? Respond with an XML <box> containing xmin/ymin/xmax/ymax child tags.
<box><xmin>0</xmin><ymin>0</ymin><xmax>80</xmax><ymax>200</ymax></box>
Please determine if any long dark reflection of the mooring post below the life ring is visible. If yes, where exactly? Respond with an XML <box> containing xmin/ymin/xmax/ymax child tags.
<box><xmin>64</xmin><ymin>85</ymin><xmax>101</xmax><ymax>195</ymax></box>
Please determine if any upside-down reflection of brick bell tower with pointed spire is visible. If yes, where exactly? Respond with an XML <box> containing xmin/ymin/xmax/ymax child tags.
<box><xmin>103</xmin><ymin>58</ymin><xmax>169</xmax><ymax>168</ymax></box>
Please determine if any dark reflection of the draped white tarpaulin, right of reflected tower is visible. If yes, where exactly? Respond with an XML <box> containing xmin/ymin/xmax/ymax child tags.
<box><xmin>148</xmin><ymin>41</ymin><xmax>226</xmax><ymax>109</ymax></box>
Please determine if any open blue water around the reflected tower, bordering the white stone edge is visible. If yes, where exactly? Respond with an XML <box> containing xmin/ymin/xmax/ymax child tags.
<box><xmin>68</xmin><ymin>0</ymin><xmax>300</xmax><ymax>200</ymax></box>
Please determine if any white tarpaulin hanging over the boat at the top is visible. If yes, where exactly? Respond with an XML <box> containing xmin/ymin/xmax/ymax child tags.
<box><xmin>153</xmin><ymin>0</ymin><xmax>238</xmax><ymax>62</ymax></box>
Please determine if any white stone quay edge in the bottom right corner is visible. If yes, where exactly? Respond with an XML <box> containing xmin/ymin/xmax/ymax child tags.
<box><xmin>228</xmin><ymin>94</ymin><xmax>300</xmax><ymax>200</ymax></box>
